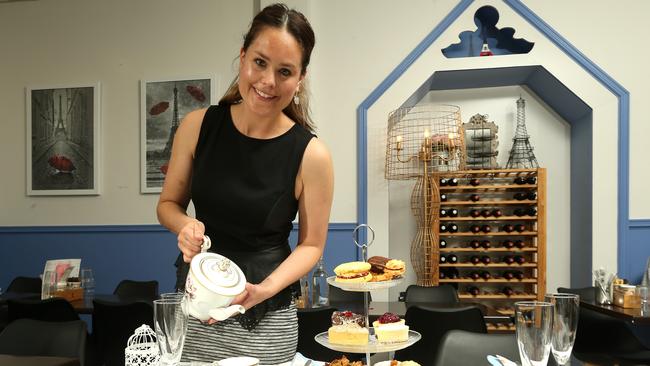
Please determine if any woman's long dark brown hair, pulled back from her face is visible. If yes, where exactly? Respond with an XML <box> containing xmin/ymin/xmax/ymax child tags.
<box><xmin>219</xmin><ymin>4</ymin><xmax>316</xmax><ymax>132</ymax></box>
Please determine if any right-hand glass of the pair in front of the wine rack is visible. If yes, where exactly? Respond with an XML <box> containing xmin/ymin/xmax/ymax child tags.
<box><xmin>544</xmin><ymin>294</ymin><xmax>580</xmax><ymax>366</ymax></box>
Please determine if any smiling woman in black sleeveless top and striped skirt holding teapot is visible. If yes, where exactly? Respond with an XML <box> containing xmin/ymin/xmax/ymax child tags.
<box><xmin>157</xmin><ymin>4</ymin><xmax>333</xmax><ymax>364</ymax></box>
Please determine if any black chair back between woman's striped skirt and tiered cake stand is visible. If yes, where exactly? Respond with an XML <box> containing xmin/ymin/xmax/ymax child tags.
<box><xmin>298</xmin><ymin>306</ymin><xmax>341</xmax><ymax>361</ymax></box>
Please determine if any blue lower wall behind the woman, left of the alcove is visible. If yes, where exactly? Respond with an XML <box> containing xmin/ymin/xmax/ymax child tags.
<box><xmin>0</xmin><ymin>223</ymin><xmax>357</xmax><ymax>293</ymax></box>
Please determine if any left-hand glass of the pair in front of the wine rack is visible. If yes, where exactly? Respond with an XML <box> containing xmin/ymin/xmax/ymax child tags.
<box><xmin>515</xmin><ymin>301</ymin><xmax>553</xmax><ymax>366</ymax></box>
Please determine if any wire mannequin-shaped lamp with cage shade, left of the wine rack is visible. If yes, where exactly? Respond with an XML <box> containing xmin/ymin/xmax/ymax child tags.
<box><xmin>385</xmin><ymin>105</ymin><xmax>466</xmax><ymax>286</ymax></box>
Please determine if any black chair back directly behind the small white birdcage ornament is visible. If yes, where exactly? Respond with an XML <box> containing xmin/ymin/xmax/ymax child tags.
<box><xmin>92</xmin><ymin>299</ymin><xmax>154</xmax><ymax>366</ymax></box>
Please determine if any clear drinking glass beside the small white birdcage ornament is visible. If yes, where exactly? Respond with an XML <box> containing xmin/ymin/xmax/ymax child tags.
<box><xmin>153</xmin><ymin>297</ymin><xmax>188</xmax><ymax>365</ymax></box>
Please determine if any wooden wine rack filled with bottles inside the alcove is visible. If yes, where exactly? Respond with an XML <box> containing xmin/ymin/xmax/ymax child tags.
<box><xmin>433</xmin><ymin>168</ymin><xmax>546</xmax><ymax>332</ymax></box>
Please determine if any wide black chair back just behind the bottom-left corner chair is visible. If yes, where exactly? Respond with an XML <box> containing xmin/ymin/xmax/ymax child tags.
<box><xmin>7</xmin><ymin>298</ymin><xmax>79</xmax><ymax>322</ymax></box>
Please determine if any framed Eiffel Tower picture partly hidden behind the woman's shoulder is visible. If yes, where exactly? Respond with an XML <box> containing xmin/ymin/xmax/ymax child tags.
<box><xmin>140</xmin><ymin>76</ymin><xmax>217</xmax><ymax>193</ymax></box>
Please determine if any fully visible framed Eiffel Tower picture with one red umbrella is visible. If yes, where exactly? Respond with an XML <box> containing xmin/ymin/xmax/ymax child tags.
<box><xmin>26</xmin><ymin>83</ymin><xmax>100</xmax><ymax>196</ymax></box>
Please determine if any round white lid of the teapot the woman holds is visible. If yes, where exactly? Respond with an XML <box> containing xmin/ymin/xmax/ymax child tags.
<box><xmin>190</xmin><ymin>253</ymin><xmax>246</xmax><ymax>296</ymax></box>
